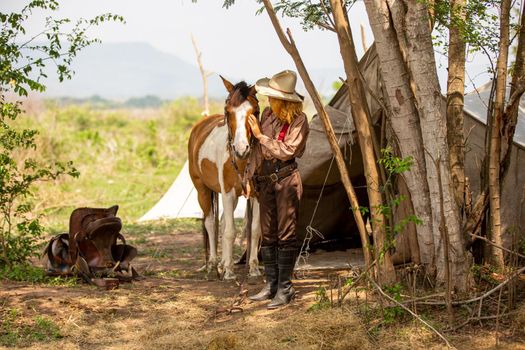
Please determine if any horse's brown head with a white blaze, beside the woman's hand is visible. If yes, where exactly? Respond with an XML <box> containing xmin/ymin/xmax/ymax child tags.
<box><xmin>221</xmin><ymin>76</ymin><xmax>259</xmax><ymax>158</ymax></box>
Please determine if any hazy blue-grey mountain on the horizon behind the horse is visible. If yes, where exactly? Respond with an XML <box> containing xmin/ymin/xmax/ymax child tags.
<box><xmin>42</xmin><ymin>43</ymin><xmax>342</xmax><ymax>100</ymax></box>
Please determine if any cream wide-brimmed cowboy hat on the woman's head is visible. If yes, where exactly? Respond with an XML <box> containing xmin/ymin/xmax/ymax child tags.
<box><xmin>255</xmin><ymin>70</ymin><xmax>304</xmax><ymax>102</ymax></box>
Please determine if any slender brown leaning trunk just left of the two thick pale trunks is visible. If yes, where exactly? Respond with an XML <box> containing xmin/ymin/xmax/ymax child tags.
<box><xmin>330</xmin><ymin>0</ymin><xmax>396</xmax><ymax>285</ymax></box>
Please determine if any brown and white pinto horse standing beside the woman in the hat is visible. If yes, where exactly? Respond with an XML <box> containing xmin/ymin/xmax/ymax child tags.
<box><xmin>188</xmin><ymin>76</ymin><xmax>261</xmax><ymax>280</ymax></box>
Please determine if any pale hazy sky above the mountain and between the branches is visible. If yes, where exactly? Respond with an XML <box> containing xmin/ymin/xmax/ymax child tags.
<box><xmin>0</xmin><ymin>0</ymin><xmax>487</xmax><ymax>90</ymax></box>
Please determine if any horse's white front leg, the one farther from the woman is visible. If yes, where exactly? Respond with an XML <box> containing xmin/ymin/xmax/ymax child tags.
<box><xmin>222</xmin><ymin>189</ymin><xmax>237</xmax><ymax>280</ymax></box>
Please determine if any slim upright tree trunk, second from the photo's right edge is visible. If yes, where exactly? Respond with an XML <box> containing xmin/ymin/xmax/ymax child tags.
<box><xmin>488</xmin><ymin>0</ymin><xmax>510</xmax><ymax>268</ymax></box>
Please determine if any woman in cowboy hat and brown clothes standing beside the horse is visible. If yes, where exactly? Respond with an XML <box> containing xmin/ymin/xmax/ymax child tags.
<box><xmin>245</xmin><ymin>70</ymin><xmax>309</xmax><ymax>309</ymax></box>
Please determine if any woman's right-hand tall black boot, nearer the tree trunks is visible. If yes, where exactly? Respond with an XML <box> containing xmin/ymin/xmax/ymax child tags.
<box><xmin>268</xmin><ymin>248</ymin><xmax>297</xmax><ymax>309</ymax></box>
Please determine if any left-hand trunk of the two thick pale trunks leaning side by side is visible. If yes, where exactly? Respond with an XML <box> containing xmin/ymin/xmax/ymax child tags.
<box><xmin>365</xmin><ymin>0</ymin><xmax>437</xmax><ymax>275</ymax></box>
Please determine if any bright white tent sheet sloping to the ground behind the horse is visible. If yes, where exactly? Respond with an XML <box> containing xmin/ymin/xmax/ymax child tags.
<box><xmin>139</xmin><ymin>161</ymin><xmax>246</xmax><ymax>222</ymax></box>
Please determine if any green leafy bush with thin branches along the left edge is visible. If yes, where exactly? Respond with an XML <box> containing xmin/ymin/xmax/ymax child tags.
<box><xmin>0</xmin><ymin>0</ymin><xmax>122</xmax><ymax>267</ymax></box>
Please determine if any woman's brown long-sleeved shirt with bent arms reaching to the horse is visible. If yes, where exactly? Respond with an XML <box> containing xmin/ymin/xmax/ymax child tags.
<box><xmin>244</xmin><ymin>107</ymin><xmax>310</xmax><ymax>180</ymax></box>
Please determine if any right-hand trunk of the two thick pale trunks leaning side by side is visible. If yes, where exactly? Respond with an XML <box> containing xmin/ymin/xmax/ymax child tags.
<box><xmin>387</xmin><ymin>0</ymin><xmax>468</xmax><ymax>290</ymax></box>
